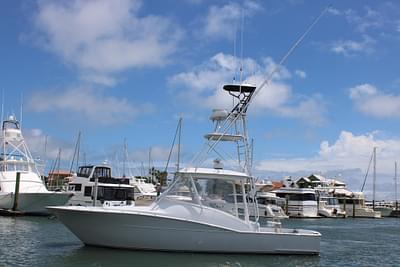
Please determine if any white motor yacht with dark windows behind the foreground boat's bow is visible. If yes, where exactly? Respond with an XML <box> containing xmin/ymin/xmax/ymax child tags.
<box><xmin>68</xmin><ymin>165</ymin><xmax>134</xmax><ymax>206</ymax></box>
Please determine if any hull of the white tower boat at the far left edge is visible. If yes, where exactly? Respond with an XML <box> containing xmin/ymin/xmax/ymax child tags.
<box><xmin>0</xmin><ymin>192</ymin><xmax>71</xmax><ymax>215</ymax></box>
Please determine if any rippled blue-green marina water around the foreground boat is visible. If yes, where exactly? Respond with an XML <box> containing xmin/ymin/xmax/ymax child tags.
<box><xmin>0</xmin><ymin>217</ymin><xmax>400</xmax><ymax>267</ymax></box>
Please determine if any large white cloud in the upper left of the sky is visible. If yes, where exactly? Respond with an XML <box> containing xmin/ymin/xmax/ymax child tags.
<box><xmin>34</xmin><ymin>0</ymin><xmax>182</xmax><ymax>79</ymax></box>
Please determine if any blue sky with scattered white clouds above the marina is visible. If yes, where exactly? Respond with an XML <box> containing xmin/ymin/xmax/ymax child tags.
<box><xmin>0</xmin><ymin>0</ymin><xmax>400</xmax><ymax>200</ymax></box>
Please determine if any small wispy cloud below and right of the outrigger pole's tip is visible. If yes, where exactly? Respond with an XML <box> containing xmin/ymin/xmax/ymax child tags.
<box><xmin>330</xmin><ymin>35</ymin><xmax>376</xmax><ymax>56</ymax></box>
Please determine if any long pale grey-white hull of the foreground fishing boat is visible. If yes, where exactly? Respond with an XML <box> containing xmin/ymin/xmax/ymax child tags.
<box><xmin>50</xmin><ymin>207</ymin><xmax>321</xmax><ymax>254</ymax></box>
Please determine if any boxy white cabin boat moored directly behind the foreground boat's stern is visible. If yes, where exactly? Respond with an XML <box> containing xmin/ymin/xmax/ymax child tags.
<box><xmin>272</xmin><ymin>187</ymin><xmax>318</xmax><ymax>218</ymax></box>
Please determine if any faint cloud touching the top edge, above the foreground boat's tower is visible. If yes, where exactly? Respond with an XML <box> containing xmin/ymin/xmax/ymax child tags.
<box><xmin>203</xmin><ymin>1</ymin><xmax>261</xmax><ymax>39</ymax></box>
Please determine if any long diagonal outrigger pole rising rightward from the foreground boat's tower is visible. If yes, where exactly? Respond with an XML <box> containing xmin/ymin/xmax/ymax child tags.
<box><xmin>192</xmin><ymin>5</ymin><xmax>331</xmax><ymax>169</ymax></box>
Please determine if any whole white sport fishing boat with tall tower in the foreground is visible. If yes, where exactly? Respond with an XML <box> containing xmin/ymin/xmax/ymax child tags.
<box><xmin>49</xmin><ymin>84</ymin><xmax>321</xmax><ymax>254</ymax></box>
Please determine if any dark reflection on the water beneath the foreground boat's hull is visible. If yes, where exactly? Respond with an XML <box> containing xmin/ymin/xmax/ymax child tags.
<box><xmin>54</xmin><ymin>246</ymin><xmax>320</xmax><ymax>267</ymax></box>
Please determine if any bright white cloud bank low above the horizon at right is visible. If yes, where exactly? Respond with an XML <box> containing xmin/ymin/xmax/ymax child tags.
<box><xmin>256</xmin><ymin>131</ymin><xmax>400</xmax><ymax>174</ymax></box>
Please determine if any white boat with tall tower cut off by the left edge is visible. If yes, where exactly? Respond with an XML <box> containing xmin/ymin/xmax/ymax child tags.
<box><xmin>0</xmin><ymin>116</ymin><xmax>72</xmax><ymax>215</ymax></box>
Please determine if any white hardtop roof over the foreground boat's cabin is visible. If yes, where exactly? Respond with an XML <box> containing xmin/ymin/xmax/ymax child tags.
<box><xmin>179</xmin><ymin>167</ymin><xmax>250</xmax><ymax>180</ymax></box>
